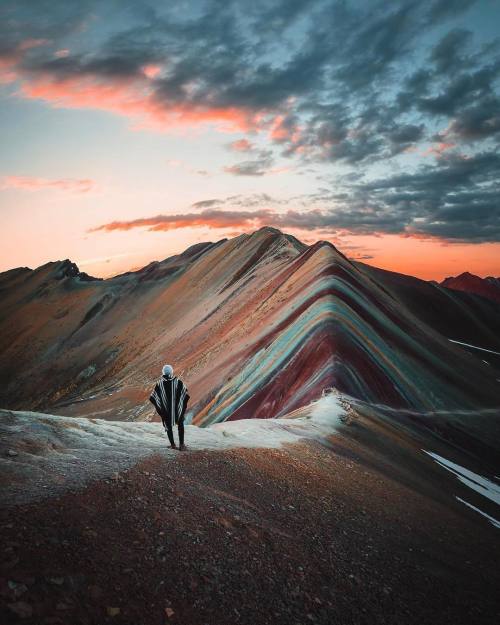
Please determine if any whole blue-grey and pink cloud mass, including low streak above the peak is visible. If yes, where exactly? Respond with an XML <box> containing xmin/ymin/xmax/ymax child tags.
<box><xmin>0</xmin><ymin>0</ymin><xmax>500</xmax><ymax>241</ymax></box>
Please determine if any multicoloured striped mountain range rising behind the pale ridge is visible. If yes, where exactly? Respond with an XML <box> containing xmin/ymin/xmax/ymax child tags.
<box><xmin>0</xmin><ymin>228</ymin><xmax>500</xmax><ymax>456</ymax></box>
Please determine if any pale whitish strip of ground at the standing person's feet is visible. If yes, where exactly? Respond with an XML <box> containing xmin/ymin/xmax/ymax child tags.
<box><xmin>0</xmin><ymin>395</ymin><xmax>344</xmax><ymax>504</ymax></box>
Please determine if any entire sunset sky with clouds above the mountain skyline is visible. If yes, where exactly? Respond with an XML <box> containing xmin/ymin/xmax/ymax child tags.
<box><xmin>0</xmin><ymin>0</ymin><xmax>500</xmax><ymax>280</ymax></box>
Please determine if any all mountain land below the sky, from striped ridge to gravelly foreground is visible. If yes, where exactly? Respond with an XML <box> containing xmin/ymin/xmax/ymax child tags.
<box><xmin>0</xmin><ymin>228</ymin><xmax>500</xmax><ymax>625</ymax></box>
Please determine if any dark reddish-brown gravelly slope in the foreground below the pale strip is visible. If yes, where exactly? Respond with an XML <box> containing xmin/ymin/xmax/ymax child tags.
<box><xmin>0</xmin><ymin>435</ymin><xmax>500</xmax><ymax>625</ymax></box>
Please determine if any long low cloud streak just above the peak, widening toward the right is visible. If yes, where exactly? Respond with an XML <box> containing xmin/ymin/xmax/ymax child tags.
<box><xmin>93</xmin><ymin>151</ymin><xmax>500</xmax><ymax>243</ymax></box>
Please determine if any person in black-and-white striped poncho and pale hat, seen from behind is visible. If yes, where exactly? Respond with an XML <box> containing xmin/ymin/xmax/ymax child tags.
<box><xmin>149</xmin><ymin>365</ymin><xmax>189</xmax><ymax>451</ymax></box>
